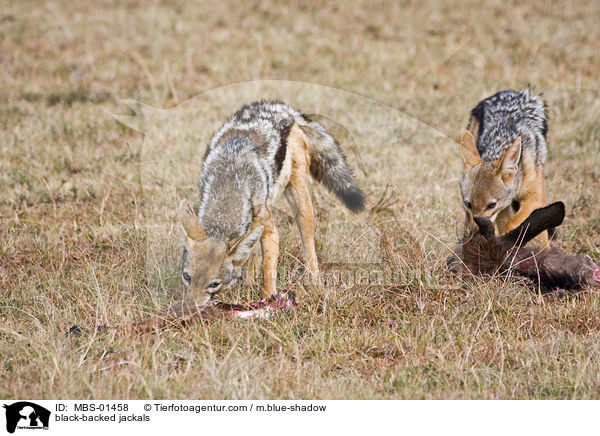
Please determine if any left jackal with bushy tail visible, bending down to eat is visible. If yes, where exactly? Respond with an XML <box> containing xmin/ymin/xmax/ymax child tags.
<box><xmin>179</xmin><ymin>101</ymin><xmax>365</xmax><ymax>304</ymax></box>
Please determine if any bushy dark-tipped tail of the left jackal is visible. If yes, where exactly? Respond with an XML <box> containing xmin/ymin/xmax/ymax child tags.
<box><xmin>296</xmin><ymin>116</ymin><xmax>365</xmax><ymax>213</ymax></box>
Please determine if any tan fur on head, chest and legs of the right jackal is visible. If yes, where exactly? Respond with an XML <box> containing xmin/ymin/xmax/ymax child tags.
<box><xmin>460</xmin><ymin>129</ymin><xmax>548</xmax><ymax>247</ymax></box>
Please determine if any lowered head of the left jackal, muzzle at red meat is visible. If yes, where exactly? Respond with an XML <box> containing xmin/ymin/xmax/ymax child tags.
<box><xmin>179</xmin><ymin>200</ymin><xmax>263</xmax><ymax>306</ymax></box>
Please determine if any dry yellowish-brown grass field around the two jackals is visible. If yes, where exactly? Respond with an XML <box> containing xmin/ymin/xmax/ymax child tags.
<box><xmin>0</xmin><ymin>1</ymin><xmax>600</xmax><ymax>398</ymax></box>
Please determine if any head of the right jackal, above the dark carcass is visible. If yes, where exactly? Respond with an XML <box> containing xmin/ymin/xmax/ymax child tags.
<box><xmin>460</xmin><ymin>130</ymin><xmax>521</xmax><ymax>225</ymax></box>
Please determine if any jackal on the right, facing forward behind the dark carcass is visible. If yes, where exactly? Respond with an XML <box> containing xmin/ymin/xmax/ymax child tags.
<box><xmin>460</xmin><ymin>90</ymin><xmax>548</xmax><ymax>246</ymax></box>
